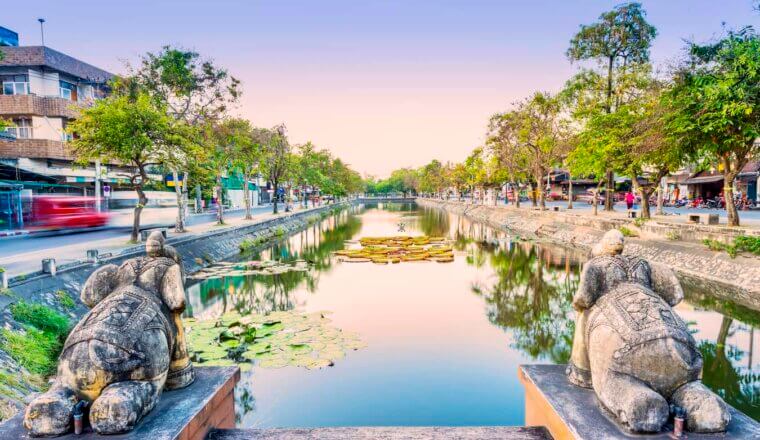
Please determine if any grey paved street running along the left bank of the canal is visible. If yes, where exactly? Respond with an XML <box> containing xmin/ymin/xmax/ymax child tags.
<box><xmin>0</xmin><ymin>205</ymin><xmax>272</xmax><ymax>276</ymax></box>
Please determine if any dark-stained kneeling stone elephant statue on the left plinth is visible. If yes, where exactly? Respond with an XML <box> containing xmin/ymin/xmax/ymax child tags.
<box><xmin>24</xmin><ymin>232</ymin><xmax>194</xmax><ymax>435</ymax></box>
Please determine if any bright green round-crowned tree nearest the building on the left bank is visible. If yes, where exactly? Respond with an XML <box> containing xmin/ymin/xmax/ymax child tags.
<box><xmin>68</xmin><ymin>93</ymin><xmax>187</xmax><ymax>242</ymax></box>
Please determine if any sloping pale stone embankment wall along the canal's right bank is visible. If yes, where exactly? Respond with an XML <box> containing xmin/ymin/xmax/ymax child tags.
<box><xmin>417</xmin><ymin>199</ymin><xmax>760</xmax><ymax>310</ymax></box>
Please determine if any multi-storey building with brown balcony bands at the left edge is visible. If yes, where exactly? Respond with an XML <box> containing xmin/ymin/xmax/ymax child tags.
<box><xmin>0</xmin><ymin>27</ymin><xmax>123</xmax><ymax>195</ymax></box>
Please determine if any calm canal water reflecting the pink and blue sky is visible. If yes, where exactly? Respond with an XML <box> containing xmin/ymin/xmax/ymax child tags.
<box><xmin>188</xmin><ymin>204</ymin><xmax>760</xmax><ymax>428</ymax></box>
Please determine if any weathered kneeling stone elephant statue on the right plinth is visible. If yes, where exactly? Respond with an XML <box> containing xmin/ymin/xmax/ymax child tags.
<box><xmin>567</xmin><ymin>230</ymin><xmax>730</xmax><ymax>432</ymax></box>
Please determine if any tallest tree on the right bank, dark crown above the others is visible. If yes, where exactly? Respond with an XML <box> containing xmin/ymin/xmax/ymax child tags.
<box><xmin>566</xmin><ymin>3</ymin><xmax>657</xmax><ymax>211</ymax></box>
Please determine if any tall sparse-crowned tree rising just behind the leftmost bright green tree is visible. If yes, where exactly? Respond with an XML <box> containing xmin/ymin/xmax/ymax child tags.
<box><xmin>125</xmin><ymin>46</ymin><xmax>241</xmax><ymax>232</ymax></box>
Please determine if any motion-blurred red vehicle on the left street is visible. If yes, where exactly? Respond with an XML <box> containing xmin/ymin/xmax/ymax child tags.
<box><xmin>32</xmin><ymin>195</ymin><xmax>110</xmax><ymax>231</ymax></box>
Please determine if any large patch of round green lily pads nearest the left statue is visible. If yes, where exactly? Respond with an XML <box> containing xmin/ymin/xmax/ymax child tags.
<box><xmin>184</xmin><ymin>311</ymin><xmax>366</xmax><ymax>369</ymax></box>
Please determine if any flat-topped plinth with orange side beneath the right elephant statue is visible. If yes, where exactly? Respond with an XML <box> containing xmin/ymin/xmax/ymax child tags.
<box><xmin>518</xmin><ymin>365</ymin><xmax>760</xmax><ymax>440</ymax></box>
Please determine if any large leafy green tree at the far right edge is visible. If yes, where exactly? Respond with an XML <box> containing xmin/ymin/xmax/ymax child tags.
<box><xmin>665</xmin><ymin>28</ymin><xmax>760</xmax><ymax>226</ymax></box>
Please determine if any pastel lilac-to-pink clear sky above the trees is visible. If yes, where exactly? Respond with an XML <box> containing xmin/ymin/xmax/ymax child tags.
<box><xmin>0</xmin><ymin>0</ymin><xmax>760</xmax><ymax>176</ymax></box>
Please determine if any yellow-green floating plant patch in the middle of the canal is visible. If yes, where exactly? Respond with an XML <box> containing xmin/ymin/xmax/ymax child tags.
<box><xmin>334</xmin><ymin>235</ymin><xmax>454</xmax><ymax>264</ymax></box>
